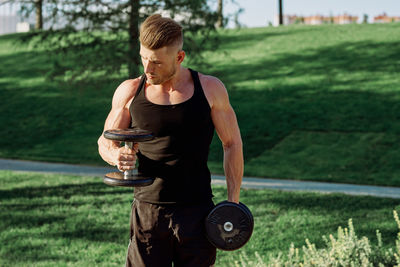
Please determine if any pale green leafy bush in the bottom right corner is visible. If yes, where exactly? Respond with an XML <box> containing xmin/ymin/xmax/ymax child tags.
<box><xmin>235</xmin><ymin>211</ymin><xmax>400</xmax><ymax>267</ymax></box>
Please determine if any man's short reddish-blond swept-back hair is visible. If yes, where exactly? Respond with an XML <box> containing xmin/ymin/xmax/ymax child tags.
<box><xmin>139</xmin><ymin>14</ymin><xmax>183</xmax><ymax>50</ymax></box>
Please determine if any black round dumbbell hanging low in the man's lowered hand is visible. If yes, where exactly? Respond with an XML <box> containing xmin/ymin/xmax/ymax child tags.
<box><xmin>205</xmin><ymin>201</ymin><xmax>254</xmax><ymax>250</ymax></box>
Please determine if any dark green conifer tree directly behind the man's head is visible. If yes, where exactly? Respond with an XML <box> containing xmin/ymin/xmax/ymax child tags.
<box><xmin>21</xmin><ymin>0</ymin><xmax>217</xmax><ymax>80</ymax></box>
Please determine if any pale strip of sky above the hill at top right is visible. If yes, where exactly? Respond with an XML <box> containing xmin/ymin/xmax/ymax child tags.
<box><xmin>224</xmin><ymin>0</ymin><xmax>400</xmax><ymax>27</ymax></box>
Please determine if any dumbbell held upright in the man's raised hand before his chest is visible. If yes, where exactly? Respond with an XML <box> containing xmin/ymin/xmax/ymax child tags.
<box><xmin>103</xmin><ymin>129</ymin><xmax>155</xmax><ymax>187</ymax></box>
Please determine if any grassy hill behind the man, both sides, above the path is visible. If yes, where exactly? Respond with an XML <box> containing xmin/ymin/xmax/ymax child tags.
<box><xmin>0</xmin><ymin>23</ymin><xmax>400</xmax><ymax>186</ymax></box>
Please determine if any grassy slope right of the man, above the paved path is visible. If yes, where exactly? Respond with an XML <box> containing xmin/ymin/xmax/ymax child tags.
<box><xmin>203</xmin><ymin>24</ymin><xmax>400</xmax><ymax>186</ymax></box>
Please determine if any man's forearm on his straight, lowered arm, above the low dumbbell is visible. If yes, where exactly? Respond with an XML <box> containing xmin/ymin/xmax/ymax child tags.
<box><xmin>224</xmin><ymin>142</ymin><xmax>243</xmax><ymax>203</ymax></box>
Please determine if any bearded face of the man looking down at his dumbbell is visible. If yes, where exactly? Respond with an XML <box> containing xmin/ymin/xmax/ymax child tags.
<box><xmin>140</xmin><ymin>45</ymin><xmax>179</xmax><ymax>85</ymax></box>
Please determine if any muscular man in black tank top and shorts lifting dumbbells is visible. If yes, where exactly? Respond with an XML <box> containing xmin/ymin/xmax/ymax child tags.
<box><xmin>98</xmin><ymin>15</ymin><xmax>243</xmax><ymax>267</ymax></box>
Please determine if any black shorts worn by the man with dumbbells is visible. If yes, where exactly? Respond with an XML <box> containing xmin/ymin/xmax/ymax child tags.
<box><xmin>126</xmin><ymin>200</ymin><xmax>216</xmax><ymax>267</ymax></box>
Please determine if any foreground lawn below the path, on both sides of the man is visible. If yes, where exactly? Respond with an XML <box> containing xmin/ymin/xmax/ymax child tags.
<box><xmin>0</xmin><ymin>171</ymin><xmax>400</xmax><ymax>266</ymax></box>
